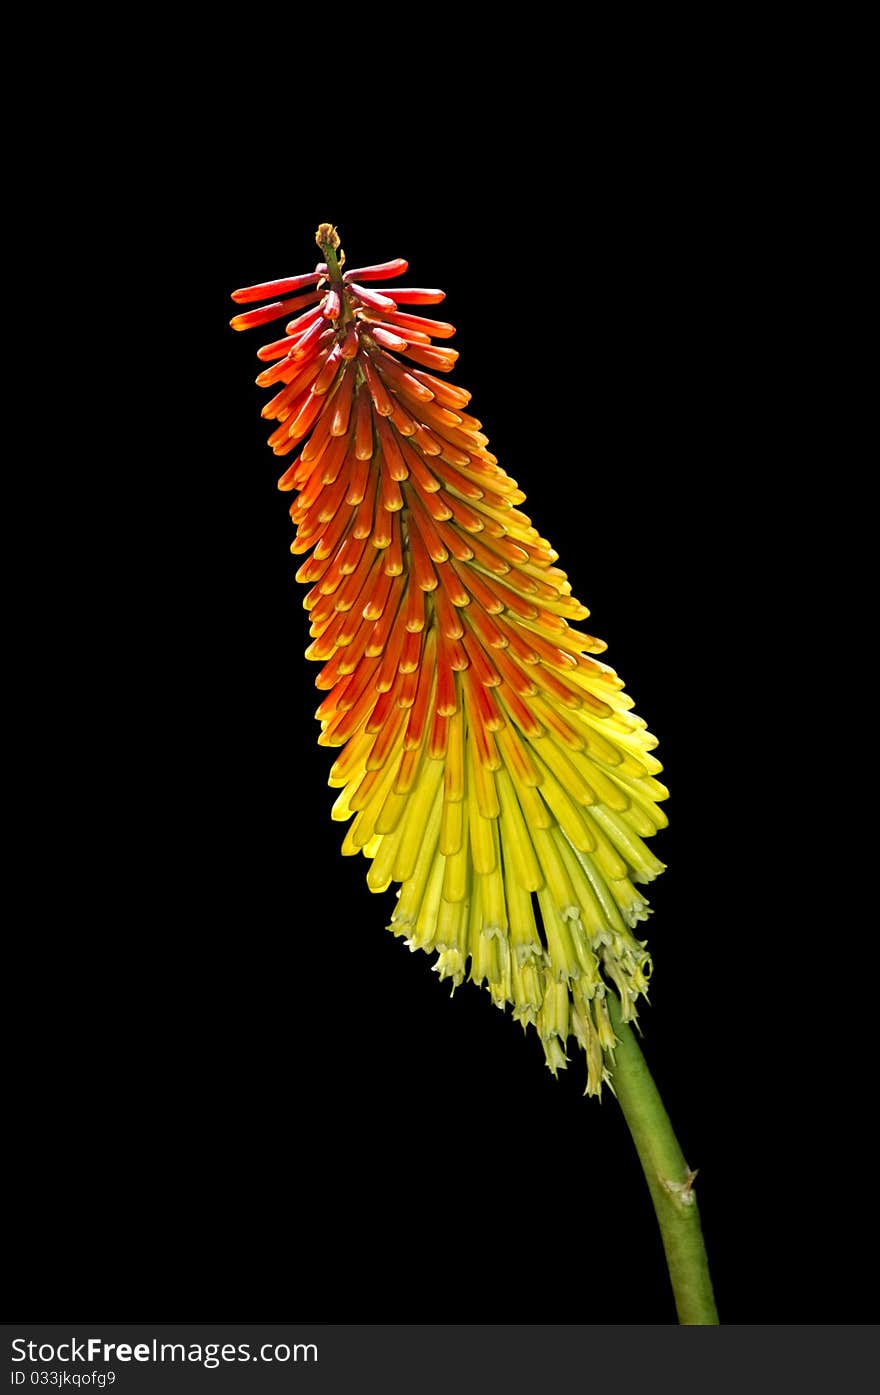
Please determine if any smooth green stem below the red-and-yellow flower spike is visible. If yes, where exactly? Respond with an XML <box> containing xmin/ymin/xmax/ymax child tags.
<box><xmin>608</xmin><ymin>993</ymin><xmax>718</xmax><ymax>1327</ymax></box>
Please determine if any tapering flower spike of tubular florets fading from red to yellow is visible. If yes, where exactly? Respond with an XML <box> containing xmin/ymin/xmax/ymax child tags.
<box><xmin>232</xmin><ymin>223</ymin><xmax>668</xmax><ymax>1095</ymax></box>
